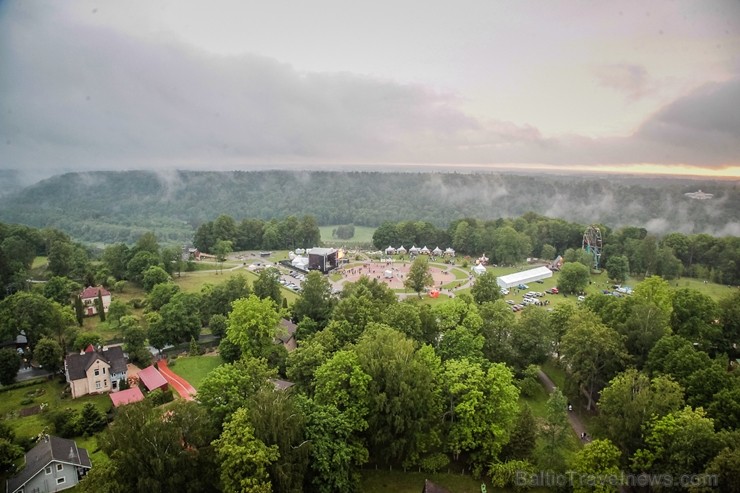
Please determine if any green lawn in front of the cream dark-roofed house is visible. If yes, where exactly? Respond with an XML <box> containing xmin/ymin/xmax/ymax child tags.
<box><xmin>0</xmin><ymin>378</ymin><xmax>112</xmax><ymax>437</ymax></box>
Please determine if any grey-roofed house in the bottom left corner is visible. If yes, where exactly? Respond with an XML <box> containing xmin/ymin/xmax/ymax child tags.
<box><xmin>6</xmin><ymin>435</ymin><xmax>92</xmax><ymax>493</ymax></box>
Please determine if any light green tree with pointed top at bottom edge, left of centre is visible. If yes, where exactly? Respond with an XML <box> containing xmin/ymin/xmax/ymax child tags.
<box><xmin>213</xmin><ymin>408</ymin><xmax>280</xmax><ymax>493</ymax></box>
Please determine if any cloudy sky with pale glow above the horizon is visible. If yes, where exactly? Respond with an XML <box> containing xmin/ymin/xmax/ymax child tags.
<box><xmin>0</xmin><ymin>0</ymin><xmax>740</xmax><ymax>181</ymax></box>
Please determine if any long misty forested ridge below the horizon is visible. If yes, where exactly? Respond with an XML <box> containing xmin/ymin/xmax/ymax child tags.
<box><xmin>0</xmin><ymin>171</ymin><xmax>740</xmax><ymax>243</ymax></box>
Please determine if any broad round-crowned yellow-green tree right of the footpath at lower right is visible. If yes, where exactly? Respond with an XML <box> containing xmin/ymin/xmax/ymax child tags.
<box><xmin>596</xmin><ymin>369</ymin><xmax>684</xmax><ymax>457</ymax></box>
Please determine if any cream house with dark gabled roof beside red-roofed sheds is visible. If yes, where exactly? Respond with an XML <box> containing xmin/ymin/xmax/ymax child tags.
<box><xmin>64</xmin><ymin>344</ymin><xmax>128</xmax><ymax>399</ymax></box>
